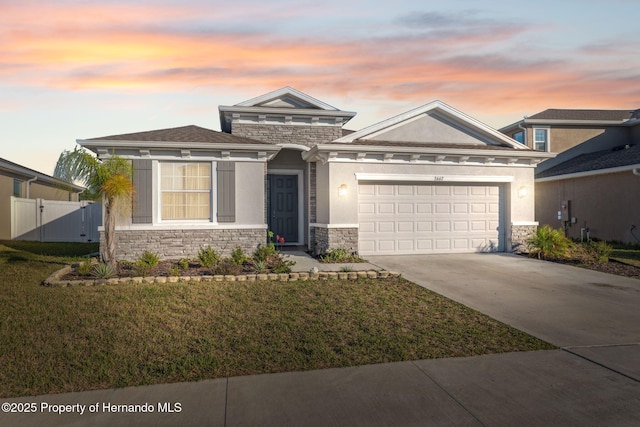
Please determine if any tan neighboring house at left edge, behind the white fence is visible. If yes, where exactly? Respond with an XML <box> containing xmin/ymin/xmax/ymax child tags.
<box><xmin>0</xmin><ymin>158</ymin><xmax>84</xmax><ymax>240</ymax></box>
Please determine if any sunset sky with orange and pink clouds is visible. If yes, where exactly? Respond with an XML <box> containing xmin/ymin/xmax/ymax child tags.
<box><xmin>0</xmin><ymin>0</ymin><xmax>640</xmax><ymax>174</ymax></box>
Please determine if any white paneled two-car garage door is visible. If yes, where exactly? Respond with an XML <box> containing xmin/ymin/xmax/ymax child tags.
<box><xmin>358</xmin><ymin>183</ymin><xmax>504</xmax><ymax>255</ymax></box>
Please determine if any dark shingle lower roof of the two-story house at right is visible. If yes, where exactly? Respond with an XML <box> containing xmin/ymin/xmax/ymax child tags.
<box><xmin>536</xmin><ymin>145</ymin><xmax>640</xmax><ymax>178</ymax></box>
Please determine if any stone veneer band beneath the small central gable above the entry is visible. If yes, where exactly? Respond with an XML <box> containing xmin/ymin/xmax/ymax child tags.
<box><xmin>231</xmin><ymin>123</ymin><xmax>342</xmax><ymax>147</ymax></box>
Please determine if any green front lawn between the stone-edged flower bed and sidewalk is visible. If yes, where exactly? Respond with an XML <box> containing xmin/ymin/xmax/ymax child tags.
<box><xmin>0</xmin><ymin>242</ymin><xmax>553</xmax><ymax>397</ymax></box>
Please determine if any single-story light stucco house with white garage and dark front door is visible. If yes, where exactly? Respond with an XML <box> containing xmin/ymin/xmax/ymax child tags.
<box><xmin>78</xmin><ymin>87</ymin><xmax>552</xmax><ymax>259</ymax></box>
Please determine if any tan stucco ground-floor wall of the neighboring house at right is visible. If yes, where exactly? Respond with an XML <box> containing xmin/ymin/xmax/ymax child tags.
<box><xmin>536</xmin><ymin>171</ymin><xmax>640</xmax><ymax>243</ymax></box>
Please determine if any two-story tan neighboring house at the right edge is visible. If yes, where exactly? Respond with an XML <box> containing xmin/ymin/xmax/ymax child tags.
<box><xmin>501</xmin><ymin>109</ymin><xmax>640</xmax><ymax>243</ymax></box>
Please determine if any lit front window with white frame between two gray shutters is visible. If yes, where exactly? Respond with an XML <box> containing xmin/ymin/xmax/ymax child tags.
<box><xmin>160</xmin><ymin>162</ymin><xmax>211</xmax><ymax>220</ymax></box>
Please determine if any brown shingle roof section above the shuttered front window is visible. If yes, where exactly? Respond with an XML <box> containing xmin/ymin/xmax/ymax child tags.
<box><xmin>86</xmin><ymin>125</ymin><xmax>272</xmax><ymax>145</ymax></box>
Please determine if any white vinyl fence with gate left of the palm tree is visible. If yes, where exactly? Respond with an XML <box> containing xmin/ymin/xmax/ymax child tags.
<box><xmin>11</xmin><ymin>197</ymin><xmax>102</xmax><ymax>242</ymax></box>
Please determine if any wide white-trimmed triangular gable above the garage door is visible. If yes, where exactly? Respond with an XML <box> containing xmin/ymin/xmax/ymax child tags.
<box><xmin>334</xmin><ymin>101</ymin><xmax>527</xmax><ymax>150</ymax></box>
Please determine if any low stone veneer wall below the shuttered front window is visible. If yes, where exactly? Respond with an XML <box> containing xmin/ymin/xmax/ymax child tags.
<box><xmin>100</xmin><ymin>228</ymin><xmax>267</xmax><ymax>261</ymax></box>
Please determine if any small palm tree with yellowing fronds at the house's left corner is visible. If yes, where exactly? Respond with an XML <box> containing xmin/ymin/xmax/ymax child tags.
<box><xmin>53</xmin><ymin>147</ymin><xmax>134</xmax><ymax>269</ymax></box>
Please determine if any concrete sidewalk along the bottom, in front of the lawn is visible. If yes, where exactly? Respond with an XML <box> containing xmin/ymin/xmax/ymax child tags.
<box><xmin>0</xmin><ymin>347</ymin><xmax>640</xmax><ymax>427</ymax></box>
